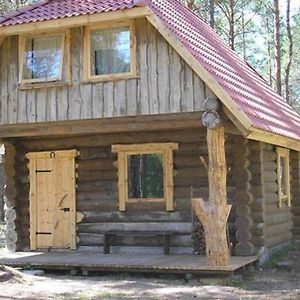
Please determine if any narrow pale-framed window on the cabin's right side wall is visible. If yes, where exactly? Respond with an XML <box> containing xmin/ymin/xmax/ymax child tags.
<box><xmin>277</xmin><ymin>147</ymin><xmax>291</xmax><ymax>207</ymax></box>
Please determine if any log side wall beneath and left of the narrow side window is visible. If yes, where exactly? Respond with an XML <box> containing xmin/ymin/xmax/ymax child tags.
<box><xmin>261</xmin><ymin>143</ymin><xmax>293</xmax><ymax>248</ymax></box>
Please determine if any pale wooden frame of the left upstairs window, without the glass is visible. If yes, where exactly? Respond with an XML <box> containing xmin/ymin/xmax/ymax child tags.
<box><xmin>19</xmin><ymin>30</ymin><xmax>71</xmax><ymax>88</ymax></box>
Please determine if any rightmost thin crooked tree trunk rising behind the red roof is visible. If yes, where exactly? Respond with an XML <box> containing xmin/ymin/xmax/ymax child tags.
<box><xmin>284</xmin><ymin>0</ymin><xmax>293</xmax><ymax>103</ymax></box>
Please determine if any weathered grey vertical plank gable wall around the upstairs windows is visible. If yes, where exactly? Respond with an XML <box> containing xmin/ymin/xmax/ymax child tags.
<box><xmin>0</xmin><ymin>19</ymin><xmax>205</xmax><ymax>124</ymax></box>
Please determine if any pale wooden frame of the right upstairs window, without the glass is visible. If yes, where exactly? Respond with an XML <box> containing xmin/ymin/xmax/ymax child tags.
<box><xmin>83</xmin><ymin>20</ymin><xmax>137</xmax><ymax>82</ymax></box>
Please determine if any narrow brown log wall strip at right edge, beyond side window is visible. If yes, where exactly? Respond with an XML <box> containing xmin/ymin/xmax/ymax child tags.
<box><xmin>290</xmin><ymin>151</ymin><xmax>300</xmax><ymax>240</ymax></box>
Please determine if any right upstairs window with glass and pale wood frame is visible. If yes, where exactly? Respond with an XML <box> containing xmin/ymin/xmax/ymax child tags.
<box><xmin>84</xmin><ymin>21</ymin><xmax>136</xmax><ymax>81</ymax></box>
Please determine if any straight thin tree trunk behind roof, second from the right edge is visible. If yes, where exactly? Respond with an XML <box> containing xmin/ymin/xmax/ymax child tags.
<box><xmin>274</xmin><ymin>0</ymin><xmax>281</xmax><ymax>95</ymax></box>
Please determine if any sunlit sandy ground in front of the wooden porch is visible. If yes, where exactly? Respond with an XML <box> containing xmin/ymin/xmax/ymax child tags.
<box><xmin>0</xmin><ymin>225</ymin><xmax>300</xmax><ymax>300</ymax></box>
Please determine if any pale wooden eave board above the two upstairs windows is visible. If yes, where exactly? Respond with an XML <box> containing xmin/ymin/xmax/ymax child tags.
<box><xmin>0</xmin><ymin>7</ymin><xmax>153</xmax><ymax>37</ymax></box>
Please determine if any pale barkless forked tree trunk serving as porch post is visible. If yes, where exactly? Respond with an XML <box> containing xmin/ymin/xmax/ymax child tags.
<box><xmin>192</xmin><ymin>126</ymin><xmax>231</xmax><ymax>266</ymax></box>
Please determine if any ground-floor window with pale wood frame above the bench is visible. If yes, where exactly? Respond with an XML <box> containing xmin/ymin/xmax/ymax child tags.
<box><xmin>112</xmin><ymin>143</ymin><xmax>178</xmax><ymax>211</ymax></box>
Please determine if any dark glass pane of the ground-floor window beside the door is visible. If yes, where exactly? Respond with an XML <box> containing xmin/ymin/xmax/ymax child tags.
<box><xmin>127</xmin><ymin>154</ymin><xmax>164</xmax><ymax>198</ymax></box>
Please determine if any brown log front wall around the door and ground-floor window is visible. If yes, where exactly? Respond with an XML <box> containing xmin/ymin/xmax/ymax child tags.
<box><xmin>11</xmin><ymin>128</ymin><xmax>234</xmax><ymax>253</ymax></box>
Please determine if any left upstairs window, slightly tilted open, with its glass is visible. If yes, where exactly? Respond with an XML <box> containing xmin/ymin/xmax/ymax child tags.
<box><xmin>20</xmin><ymin>32</ymin><xmax>69</xmax><ymax>84</ymax></box>
